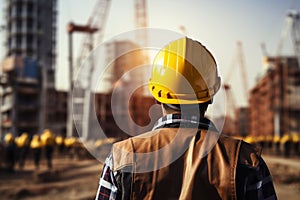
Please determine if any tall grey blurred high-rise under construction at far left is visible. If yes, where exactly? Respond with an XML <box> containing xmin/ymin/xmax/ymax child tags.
<box><xmin>0</xmin><ymin>0</ymin><xmax>57</xmax><ymax>138</ymax></box>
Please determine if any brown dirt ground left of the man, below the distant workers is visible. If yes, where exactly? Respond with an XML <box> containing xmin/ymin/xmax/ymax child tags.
<box><xmin>0</xmin><ymin>158</ymin><xmax>102</xmax><ymax>200</ymax></box>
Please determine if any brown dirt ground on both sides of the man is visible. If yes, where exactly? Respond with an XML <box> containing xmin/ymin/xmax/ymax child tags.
<box><xmin>0</xmin><ymin>153</ymin><xmax>300</xmax><ymax>200</ymax></box>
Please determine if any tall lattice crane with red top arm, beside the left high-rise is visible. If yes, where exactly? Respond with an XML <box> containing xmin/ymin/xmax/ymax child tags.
<box><xmin>67</xmin><ymin>0</ymin><xmax>111</xmax><ymax>139</ymax></box>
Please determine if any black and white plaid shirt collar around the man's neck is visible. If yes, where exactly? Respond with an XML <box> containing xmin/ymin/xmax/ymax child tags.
<box><xmin>152</xmin><ymin>113</ymin><xmax>218</xmax><ymax>132</ymax></box>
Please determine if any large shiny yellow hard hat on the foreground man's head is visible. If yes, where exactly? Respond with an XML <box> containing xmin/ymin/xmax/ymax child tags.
<box><xmin>148</xmin><ymin>37</ymin><xmax>221</xmax><ymax>104</ymax></box>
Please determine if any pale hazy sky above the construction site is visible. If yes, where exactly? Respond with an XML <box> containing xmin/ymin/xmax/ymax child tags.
<box><xmin>0</xmin><ymin>0</ymin><xmax>300</xmax><ymax>107</ymax></box>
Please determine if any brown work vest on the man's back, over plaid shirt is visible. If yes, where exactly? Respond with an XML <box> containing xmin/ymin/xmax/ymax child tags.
<box><xmin>112</xmin><ymin>128</ymin><xmax>259</xmax><ymax>200</ymax></box>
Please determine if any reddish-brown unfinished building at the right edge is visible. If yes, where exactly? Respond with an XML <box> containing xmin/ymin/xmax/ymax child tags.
<box><xmin>249</xmin><ymin>57</ymin><xmax>300</xmax><ymax>136</ymax></box>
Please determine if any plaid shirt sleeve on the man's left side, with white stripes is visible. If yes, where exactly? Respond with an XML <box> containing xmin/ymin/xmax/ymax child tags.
<box><xmin>95</xmin><ymin>155</ymin><xmax>119</xmax><ymax>200</ymax></box>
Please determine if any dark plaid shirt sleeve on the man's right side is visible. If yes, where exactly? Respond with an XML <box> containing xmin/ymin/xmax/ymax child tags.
<box><xmin>236</xmin><ymin>158</ymin><xmax>277</xmax><ymax>200</ymax></box>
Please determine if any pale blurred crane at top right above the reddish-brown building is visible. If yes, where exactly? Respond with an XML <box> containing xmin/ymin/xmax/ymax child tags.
<box><xmin>277</xmin><ymin>10</ymin><xmax>300</xmax><ymax>66</ymax></box>
